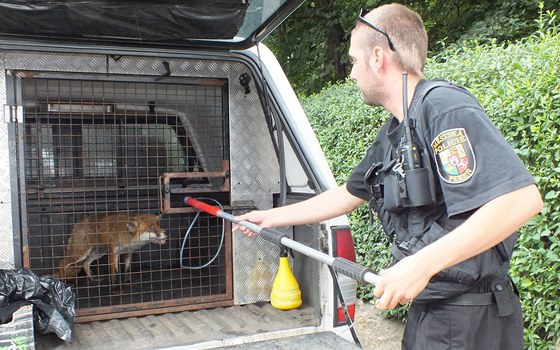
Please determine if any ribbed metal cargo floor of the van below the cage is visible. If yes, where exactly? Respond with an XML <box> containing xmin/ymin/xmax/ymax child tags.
<box><xmin>35</xmin><ymin>303</ymin><xmax>326</xmax><ymax>350</ymax></box>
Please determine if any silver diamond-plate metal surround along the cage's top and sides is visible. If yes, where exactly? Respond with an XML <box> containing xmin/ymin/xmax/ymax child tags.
<box><xmin>0</xmin><ymin>50</ymin><xmax>280</xmax><ymax>304</ymax></box>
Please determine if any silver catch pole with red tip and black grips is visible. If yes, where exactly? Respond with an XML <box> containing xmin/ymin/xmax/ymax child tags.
<box><xmin>184</xmin><ymin>196</ymin><xmax>380</xmax><ymax>285</ymax></box>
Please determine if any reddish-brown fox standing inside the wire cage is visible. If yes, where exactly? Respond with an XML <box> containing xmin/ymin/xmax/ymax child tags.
<box><xmin>53</xmin><ymin>214</ymin><xmax>167</xmax><ymax>284</ymax></box>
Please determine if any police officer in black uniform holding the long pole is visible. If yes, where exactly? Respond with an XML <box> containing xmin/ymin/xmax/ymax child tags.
<box><xmin>233</xmin><ymin>4</ymin><xmax>543</xmax><ymax>350</ymax></box>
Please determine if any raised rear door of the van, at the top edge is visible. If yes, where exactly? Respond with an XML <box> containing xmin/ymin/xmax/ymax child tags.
<box><xmin>0</xmin><ymin>0</ymin><xmax>304</xmax><ymax>49</ymax></box>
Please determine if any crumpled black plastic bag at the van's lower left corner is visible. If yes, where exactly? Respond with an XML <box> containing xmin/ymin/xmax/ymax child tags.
<box><xmin>0</xmin><ymin>269</ymin><xmax>75</xmax><ymax>342</ymax></box>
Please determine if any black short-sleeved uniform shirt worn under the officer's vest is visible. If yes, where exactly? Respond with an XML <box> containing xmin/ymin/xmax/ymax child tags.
<box><xmin>346</xmin><ymin>80</ymin><xmax>535</xmax><ymax>217</ymax></box>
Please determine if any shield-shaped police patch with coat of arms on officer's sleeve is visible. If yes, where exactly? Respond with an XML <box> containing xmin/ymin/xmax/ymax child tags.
<box><xmin>432</xmin><ymin>128</ymin><xmax>476</xmax><ymax>184</ymax></box>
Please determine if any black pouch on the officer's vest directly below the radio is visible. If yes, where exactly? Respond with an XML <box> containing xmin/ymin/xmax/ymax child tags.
<box><xmin>404</xmin><ymin>168</ymin><xmax>436</xmax><ymax>207</ymax></box>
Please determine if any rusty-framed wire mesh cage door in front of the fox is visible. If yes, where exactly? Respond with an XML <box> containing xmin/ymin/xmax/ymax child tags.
<box><xmin>20</xmin><ymin>77</ymin><xmax>232</xmax><ymax>321</ymax></box>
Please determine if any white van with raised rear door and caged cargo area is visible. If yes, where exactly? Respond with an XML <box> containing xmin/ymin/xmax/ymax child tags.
<box><xmin>0</xmin><ymin>0</ymin><xmax>364</xmax><ymax>349</ymax></box>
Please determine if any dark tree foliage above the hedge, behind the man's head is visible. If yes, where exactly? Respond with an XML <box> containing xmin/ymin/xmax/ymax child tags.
<box><xmin>265</xmin><ymin>0</ymin><xmax>560</xmax><ymax>95</ymax></box>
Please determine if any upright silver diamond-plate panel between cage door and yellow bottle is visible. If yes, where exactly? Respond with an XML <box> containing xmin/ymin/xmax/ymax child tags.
<box><xmin>226</xmin><ymin>57</ymin><xmax>280</xmax><ymax>304</ymax></box>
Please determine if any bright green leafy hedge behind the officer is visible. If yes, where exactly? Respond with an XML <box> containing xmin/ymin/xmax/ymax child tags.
<box><xmin>302</xmin><ymin>13</ymin><xmax>560</xmax><ymax>349</ymax></box>
